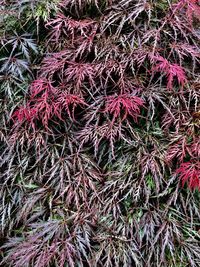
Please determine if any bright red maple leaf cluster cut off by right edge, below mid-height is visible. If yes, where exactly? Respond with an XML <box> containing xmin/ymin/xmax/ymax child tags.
<box><xmin>176</xmin><ymin>162</ymin><xmax>200</xmax><ymax>190</ymax></box>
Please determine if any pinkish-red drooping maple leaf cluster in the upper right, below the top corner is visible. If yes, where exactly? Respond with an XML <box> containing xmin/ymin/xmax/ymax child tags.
<box><xmin>152</xmin><ymin>56</ymin><xmax>187</xmax><ymax>90</ymax></box>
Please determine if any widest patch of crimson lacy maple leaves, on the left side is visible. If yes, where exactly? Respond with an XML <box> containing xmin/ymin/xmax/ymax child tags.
<box><xmin>13</xmin><ymin>80</ymin><xmax>86</xmax><ymax>128</ymax></box>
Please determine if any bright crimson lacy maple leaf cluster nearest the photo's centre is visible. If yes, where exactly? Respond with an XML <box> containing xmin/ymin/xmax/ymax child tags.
<box><xmin>105</xmin><ymin>94</ymin><xmax>144</xmax><ymax>122</ymax></box>
